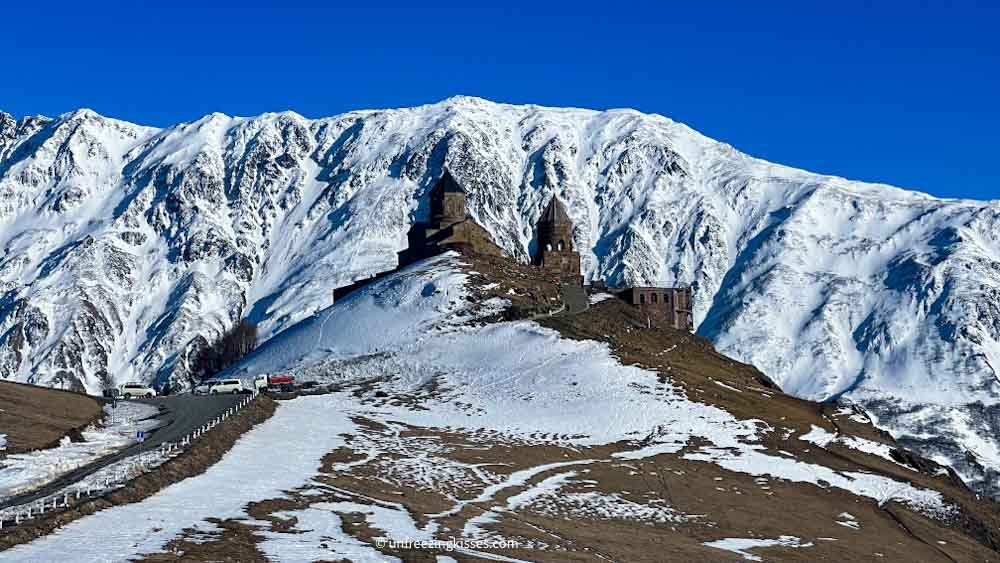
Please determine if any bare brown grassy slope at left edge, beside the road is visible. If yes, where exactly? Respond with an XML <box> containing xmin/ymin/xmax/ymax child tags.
<box><xmin>0</xmin><ymin>381</ymin><xmax>101</xmax><ymax>454</ymax></box>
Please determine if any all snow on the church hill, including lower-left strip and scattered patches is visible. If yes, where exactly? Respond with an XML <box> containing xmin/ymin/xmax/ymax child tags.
<box><xmin>6</xmin><ymin>254</ymin><xmax>954</xmax><ymax>561</ymax></box>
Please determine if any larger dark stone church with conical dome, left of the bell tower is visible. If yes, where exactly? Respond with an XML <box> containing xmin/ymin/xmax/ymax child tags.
<box><xmin>399</xmin><ymin>169</ymin><xmax>503</xmax><ymax>266</ymax></box>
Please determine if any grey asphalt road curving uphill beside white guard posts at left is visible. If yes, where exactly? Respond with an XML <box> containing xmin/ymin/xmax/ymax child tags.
<box><xmin>0</xmin><ymin>395</ymin><xmax>246</xmax><ymax>510</ymax></box>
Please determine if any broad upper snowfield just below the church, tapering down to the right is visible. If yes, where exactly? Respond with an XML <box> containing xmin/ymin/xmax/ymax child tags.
<box><xmin>217</xmin><ymin>253</ymin><xmax>947</xmax><ymax>512</ymax></box>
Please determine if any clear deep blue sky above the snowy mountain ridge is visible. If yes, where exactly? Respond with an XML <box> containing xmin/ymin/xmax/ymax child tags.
<box><xmin>0</xmin><ymin>0</ymin><xmax>1000</xmax><ymax>199</ymax></box>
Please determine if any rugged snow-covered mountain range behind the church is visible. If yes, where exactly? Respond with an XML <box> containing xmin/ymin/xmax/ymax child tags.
<box><xmin>0</xmin><ymin>97</ymin><xmax>1000</xmax><ymax>498</ymax></box>
